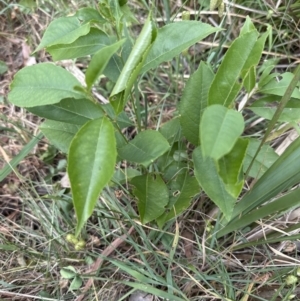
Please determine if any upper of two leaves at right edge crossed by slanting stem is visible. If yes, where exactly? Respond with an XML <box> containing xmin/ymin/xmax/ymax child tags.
<box><xmin>259</xmin><ymin>72</ymin><xmax>300</xmax><ymax>99</ymax></box>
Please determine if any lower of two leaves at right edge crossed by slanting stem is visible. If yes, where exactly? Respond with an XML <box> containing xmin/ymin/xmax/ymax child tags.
<box><xmin>249</xmin><ymin>95</ymin><xmax>300</xmax><ymax>122</ymax></box>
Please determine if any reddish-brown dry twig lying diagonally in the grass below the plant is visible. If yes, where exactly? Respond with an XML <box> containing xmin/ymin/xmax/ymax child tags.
<box><xmin>75</xmin><ymin>226</ymin><xmax>134</xmax><ymax>301</ymax></box>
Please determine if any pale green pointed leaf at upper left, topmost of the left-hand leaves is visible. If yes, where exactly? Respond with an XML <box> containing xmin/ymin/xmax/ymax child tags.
<box><xmin>34</xmin><ymin>16</ymin><xmax>90</xmax><ymax>52</ymax></box>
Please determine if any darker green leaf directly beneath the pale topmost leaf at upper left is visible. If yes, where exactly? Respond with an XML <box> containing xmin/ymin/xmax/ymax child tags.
<box><xmin>47</xmin><ymin>28</ymin><xmax>111</xmax><ymax>61</ymax></box>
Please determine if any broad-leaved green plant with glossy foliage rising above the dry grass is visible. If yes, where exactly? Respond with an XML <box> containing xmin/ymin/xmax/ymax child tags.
<box><xmin>9</xmin><ymin>0</ymin><xmax>300</xmax><ymax>239</ymax></box>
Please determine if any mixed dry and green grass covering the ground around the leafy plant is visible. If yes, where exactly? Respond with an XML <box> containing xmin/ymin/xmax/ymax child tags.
<box><xmin>0</xmin><ymin>0</ymin><xmax>300</xmax><ymax>301</ymax></box>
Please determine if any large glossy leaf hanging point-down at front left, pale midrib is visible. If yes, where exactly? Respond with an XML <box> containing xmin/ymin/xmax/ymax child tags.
<box><xmin>68</xmin><ymin>117</ymin><xmax>117</xmax><ymax>236</ymax></box>
